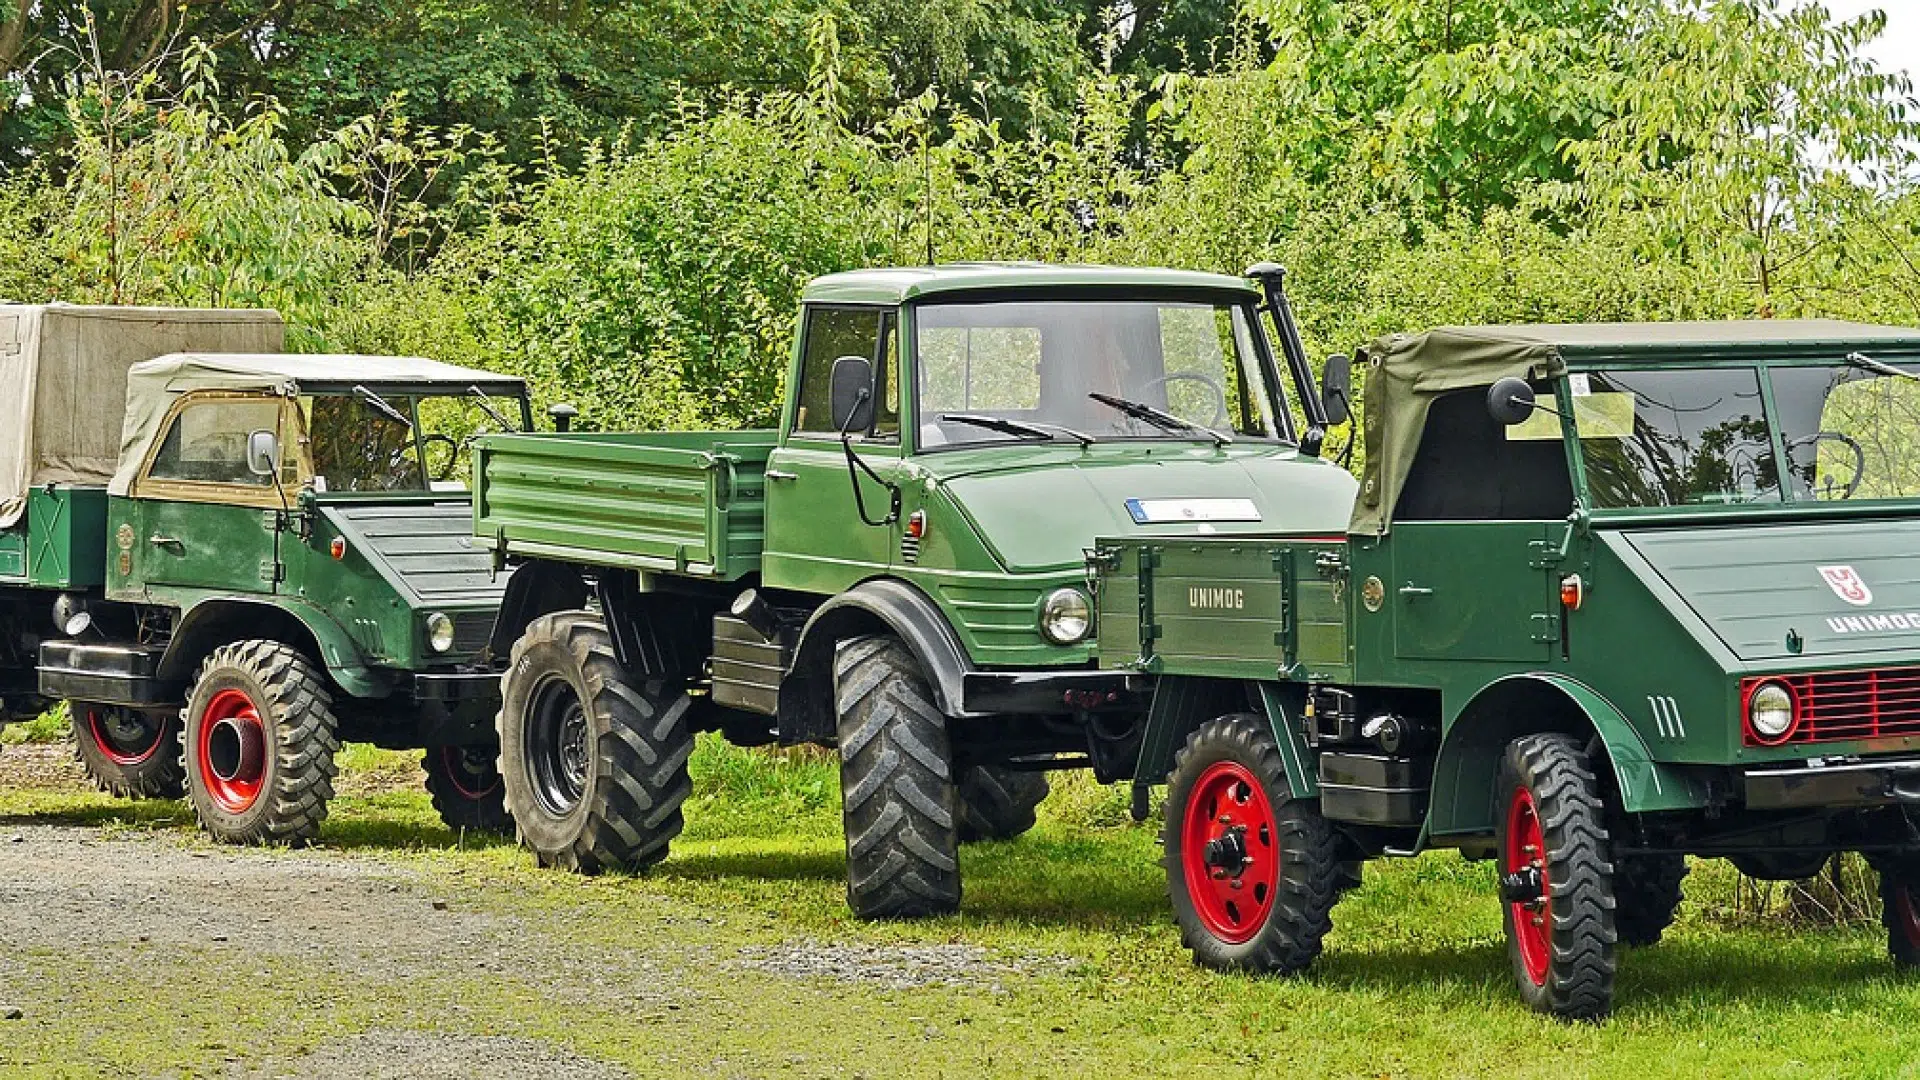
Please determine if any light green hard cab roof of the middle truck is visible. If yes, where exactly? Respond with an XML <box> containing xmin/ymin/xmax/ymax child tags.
<box><xmin>801</xmin><ymin>263</ymin><xmax>1258</xmax><ymax>304</ymax></box>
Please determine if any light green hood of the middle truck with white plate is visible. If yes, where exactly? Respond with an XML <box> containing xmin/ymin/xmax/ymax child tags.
<box><xmin>941</xmin><ymin>448</ymin><xmax>1357</xmax><ymax>573</ymax></box>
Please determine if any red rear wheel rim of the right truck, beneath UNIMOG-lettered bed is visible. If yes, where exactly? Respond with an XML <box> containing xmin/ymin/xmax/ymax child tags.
<box><xmin>1181</xmin><ymin>761</ymin><xmax>1281</xmax><ymax>945</ymax></box>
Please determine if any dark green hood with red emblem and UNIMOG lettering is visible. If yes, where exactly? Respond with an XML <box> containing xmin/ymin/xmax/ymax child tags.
<box><xmin>1601</xmin><ymin>521</ymin><xmax>1920</xmax><ymax>661</ymax></box>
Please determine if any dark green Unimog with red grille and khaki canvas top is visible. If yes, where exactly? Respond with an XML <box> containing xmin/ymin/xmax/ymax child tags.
<box><xmin>1091</xmin><ymin>321</ymin><xmax>1920</xmax><ymax>1019</ymax></box>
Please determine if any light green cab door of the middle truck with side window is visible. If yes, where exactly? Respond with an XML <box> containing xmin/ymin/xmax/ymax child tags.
<box><xmin>762</xmin><ymin>306</ymin><xmax>900</xmax><ymax>592</ymax></box>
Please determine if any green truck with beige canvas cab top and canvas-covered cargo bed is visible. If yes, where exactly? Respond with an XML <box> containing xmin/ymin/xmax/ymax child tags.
<box><xmin>0</xmin><ymin>306</ymin><xmax>530</xmax><ymax>844</ymax></box>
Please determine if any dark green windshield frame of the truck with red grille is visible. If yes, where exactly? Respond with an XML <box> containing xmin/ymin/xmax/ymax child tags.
<box><xmin>1551</xmin><ymin>342</ymin><xmax>1920</xmax><ymax>525</ymax></box>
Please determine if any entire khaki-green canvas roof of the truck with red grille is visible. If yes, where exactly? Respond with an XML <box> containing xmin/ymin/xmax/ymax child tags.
<box><xmin>1350</xmin><ymin>319</ymin><xmax>1920</xmax><ymax>534</ymax></box>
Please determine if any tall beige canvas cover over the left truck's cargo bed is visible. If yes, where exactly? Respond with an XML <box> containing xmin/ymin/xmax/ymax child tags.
<box><xmin>0</xmin><ymin>304</ymin><xmax>284</xmax><ymax>528</ymax></box>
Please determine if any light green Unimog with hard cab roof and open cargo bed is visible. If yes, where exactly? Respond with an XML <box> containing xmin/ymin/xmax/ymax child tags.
<box><xmin>474</xmin><ymin>265</ymin><xmax>1354</xmax><ymax>917</ymax></box>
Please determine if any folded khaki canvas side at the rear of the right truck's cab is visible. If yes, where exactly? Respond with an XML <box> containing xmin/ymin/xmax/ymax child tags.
<box><xmin>1348</xmin><ymin>327</ymin><xmax>1565</xmax><ymax>536</ymax></box>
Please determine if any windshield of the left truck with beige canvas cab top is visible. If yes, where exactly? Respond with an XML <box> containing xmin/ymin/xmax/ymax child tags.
<box><xmin>300</xmin><ymin>390</ymin><xmax>522</xmax><ymax>492</ymax></box>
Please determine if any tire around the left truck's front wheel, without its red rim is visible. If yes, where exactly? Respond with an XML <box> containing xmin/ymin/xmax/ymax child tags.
<box><xmin>180</xmin><ymin>640</ymin><xmax>340</xmax><ymax>847</ymax></box>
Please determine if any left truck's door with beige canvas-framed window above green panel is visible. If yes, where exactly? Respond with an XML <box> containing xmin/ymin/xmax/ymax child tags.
<box><xmin>115</xmin><ymin>392</ymin><xmax>296</xmax><ymax>594</ymax></box>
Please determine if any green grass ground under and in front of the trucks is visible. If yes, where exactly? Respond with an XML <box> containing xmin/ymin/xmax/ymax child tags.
<box><xmin>0</xmin><ymin>744</ymin><xmax>1920</xmax><ymax>1080</ymax></box>
